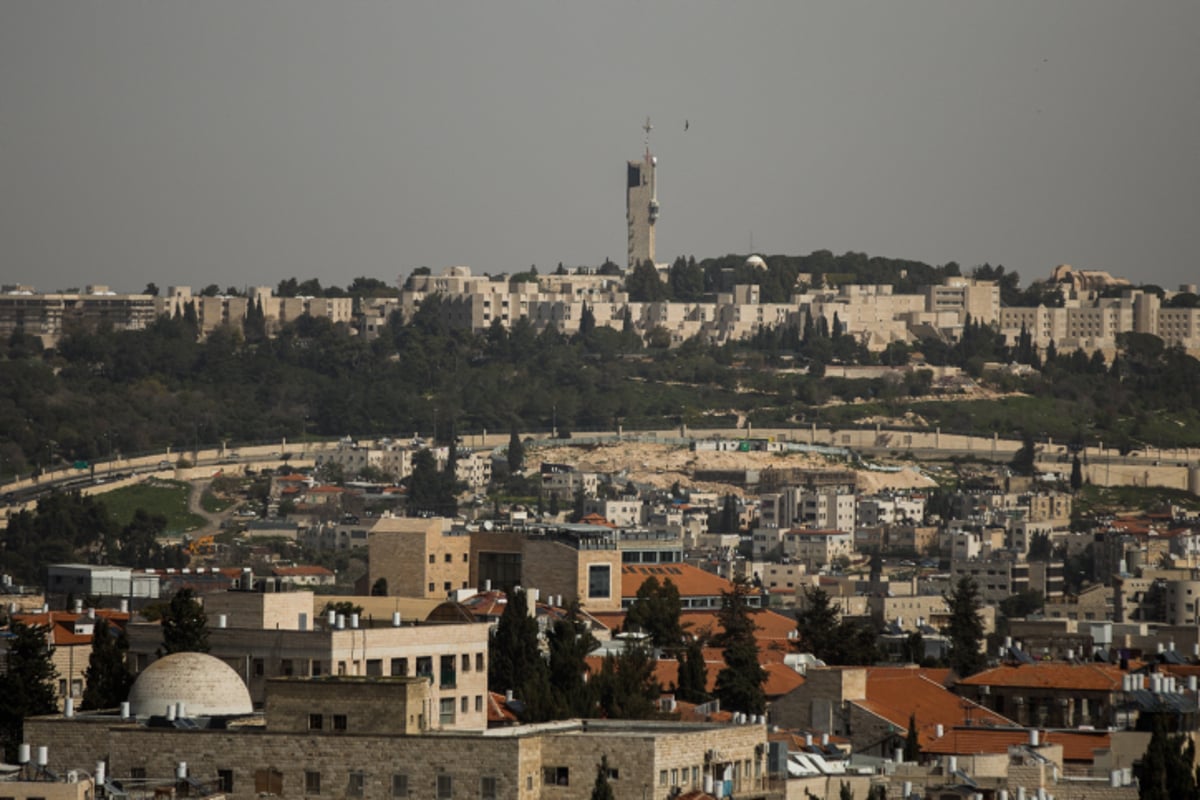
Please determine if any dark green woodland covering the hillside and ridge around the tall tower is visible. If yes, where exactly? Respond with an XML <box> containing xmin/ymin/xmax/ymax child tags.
<box><xmin>0</xmin><ymin>260</ymin><xmax>1200</xmax><ymax>476</ymax></box>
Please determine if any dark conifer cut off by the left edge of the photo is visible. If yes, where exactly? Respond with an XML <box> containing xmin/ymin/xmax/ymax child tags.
<box><xmin>0</xmin><ymin>622</ymin><xmax>58</xmax><ymax>764</ymax></box>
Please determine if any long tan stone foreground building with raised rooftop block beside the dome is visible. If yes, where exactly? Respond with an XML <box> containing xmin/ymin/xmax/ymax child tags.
<box><xmin>25</xmin><ymin>654</ymin><xmax>778</xmax><ymax>800</ymax></box>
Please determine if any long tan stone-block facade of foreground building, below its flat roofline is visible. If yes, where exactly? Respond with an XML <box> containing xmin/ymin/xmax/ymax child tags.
<box><xmin>28</xmin><ymin>717</ymin><xmax>766</xmax><ymax>800</ymax></box>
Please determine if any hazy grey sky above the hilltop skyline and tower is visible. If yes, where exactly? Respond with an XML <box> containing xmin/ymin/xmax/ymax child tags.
<box><xmin>0</xmin><ymin>0</ymin><xmax>1200</xmax><ymax>290</ymax></box>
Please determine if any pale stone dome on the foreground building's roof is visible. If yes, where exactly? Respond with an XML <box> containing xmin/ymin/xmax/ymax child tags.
<box><xmin>130</xmin><ymin>652</ymin><xmax>254</xmax><ymax>717</ymax></box>
